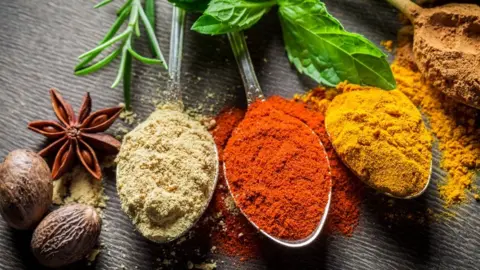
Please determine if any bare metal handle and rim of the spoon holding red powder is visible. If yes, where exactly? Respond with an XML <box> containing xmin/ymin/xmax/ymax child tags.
<box><xmin>223</xmin><ymin>32</ymin><xmax>332</xmax><ymax>248</ymax></box>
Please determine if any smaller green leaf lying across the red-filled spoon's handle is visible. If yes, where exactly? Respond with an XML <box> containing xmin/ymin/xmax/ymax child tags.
<box><xmin>192</xmin><ymin>0</ymin><xmax>277</xmax><ymax>35</ymax></box>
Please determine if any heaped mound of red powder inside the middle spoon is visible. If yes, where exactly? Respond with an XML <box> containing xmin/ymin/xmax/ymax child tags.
<box><xmin>224</xmin><ymin>98</ymin><xmax>331</xmax><ymax>240</ymax></box>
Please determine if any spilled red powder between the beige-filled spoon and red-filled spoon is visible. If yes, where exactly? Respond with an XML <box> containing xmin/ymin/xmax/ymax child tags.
<box><xmin>208</xmin><ymin>108</ymin><xmax>259</xmax><ymax>260</ymax></box>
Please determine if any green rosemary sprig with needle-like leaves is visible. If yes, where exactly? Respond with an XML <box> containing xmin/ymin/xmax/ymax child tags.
<box><xmin>75</xmin><ymin>0</ymin><xmax>167</xmax><ymax>109</ymax></box>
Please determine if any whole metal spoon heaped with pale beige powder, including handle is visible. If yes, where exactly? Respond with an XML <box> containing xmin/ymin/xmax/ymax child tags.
<box><xmin>117</xmin><ymin>7</ymin><xmax>219</xmax><ymax>243</ymax></box>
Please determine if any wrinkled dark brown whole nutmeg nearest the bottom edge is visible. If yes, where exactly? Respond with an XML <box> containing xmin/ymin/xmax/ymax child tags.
<box><xmin>31</xmin><ymin>204</ymin><xmax>102</xmax><ymax>267</ymax></box>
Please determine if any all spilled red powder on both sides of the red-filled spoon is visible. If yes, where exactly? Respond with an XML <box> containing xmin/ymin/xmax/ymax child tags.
<box><xmin>208</xmin><ymin>95</ymin><xmax>363</xmax><ymax>259</ymax></box>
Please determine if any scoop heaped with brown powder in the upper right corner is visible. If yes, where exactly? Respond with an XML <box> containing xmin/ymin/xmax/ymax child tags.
<box><xmin>387</xmin><ymin>0</ymin><xmax>480</xmax><ymax>109</ymax></box>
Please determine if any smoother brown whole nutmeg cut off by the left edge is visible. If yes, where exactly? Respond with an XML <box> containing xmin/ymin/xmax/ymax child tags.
<box><xmin>0</xmin><ymin>149</ymin><xmax>53</xmax><ymax>230</ymax></box>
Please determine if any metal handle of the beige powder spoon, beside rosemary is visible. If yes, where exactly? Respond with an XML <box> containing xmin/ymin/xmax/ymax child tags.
<box><xmin>167</xmin><ymin>6</ymin><xmax>186</xmax><ymax>103</ymax></box>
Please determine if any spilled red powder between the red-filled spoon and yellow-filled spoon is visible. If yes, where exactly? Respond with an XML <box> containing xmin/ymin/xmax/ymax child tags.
<box><xmin>267</xmin><ymin>95</ymin><xmax>363</xmax><ymax>236</ymax></box>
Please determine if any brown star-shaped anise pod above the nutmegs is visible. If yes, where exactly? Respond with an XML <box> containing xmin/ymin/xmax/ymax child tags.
<box><xmin>28</xmin><ymin>89</ymin><xmax>123</xmax><ymax>179</ymax></box>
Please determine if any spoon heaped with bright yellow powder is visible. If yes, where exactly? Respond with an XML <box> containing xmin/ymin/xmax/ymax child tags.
<box><xmin>325</xmin><ymin>89</ymin><xmax>432</xmax><ymax>199</ymax></box>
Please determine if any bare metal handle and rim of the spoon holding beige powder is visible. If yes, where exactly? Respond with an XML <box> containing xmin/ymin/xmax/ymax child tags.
<box><xmin>117</xmin><ymin>6</ymin><xmax>219</xmax><ymax>244</ymax></box>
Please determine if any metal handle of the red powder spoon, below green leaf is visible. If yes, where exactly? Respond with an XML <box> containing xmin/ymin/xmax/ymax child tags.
<box><xmin>228</xmin><ymin>32</ymin><xmax>265</xmax><ymax>105</ymax></box>
